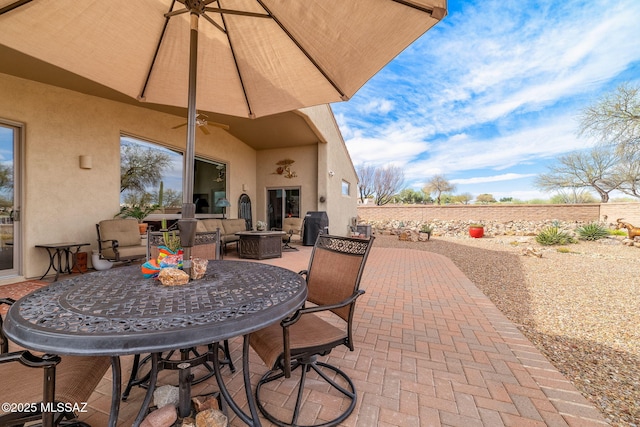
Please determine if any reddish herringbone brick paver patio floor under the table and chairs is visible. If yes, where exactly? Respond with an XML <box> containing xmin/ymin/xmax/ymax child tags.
<box><xmin>0</xmin><ymin>246</ymin><xmax>607</xmax><ymax>427</ymax></box>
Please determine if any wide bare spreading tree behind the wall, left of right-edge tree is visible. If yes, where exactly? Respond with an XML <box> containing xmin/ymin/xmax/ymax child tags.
<box><xmin>535</xmin><ymin>147</ymin><xmax>621</xmax><ymax>203</ymax></box>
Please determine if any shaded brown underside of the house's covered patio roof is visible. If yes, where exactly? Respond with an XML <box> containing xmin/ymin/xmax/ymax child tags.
<box><xmin>0</xmin><ymin>45</ymin><xmax>326</xmax><ymax>150</ymax></box>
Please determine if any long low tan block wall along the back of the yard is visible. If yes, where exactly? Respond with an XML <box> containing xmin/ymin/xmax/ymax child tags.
<box><xmin>358</xmin><ymin>203</ymin><xmax>640</xmax><ymax>226</ymax></box>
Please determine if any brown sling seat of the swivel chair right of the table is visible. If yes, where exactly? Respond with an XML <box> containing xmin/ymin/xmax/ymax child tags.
<box><xmin>250</xmin><ymin>314</ymin><xmax>347</xmax><ymax>367</ymax></box>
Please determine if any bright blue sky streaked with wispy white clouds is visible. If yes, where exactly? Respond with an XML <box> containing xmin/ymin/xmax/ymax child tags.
<box><xmin>332</xmin><ymin>0</ymin><xmax>640</xmax><ymax>200</ymax></box>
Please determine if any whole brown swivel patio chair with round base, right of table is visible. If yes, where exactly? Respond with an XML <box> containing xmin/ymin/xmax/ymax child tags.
<box><xmin>249</xmin><ymin>234</ymin><xmax>374</xmax><ymax>426</ymax></box>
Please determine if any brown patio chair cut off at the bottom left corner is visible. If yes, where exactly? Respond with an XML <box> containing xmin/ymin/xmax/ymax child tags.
<box><xmin>0</xmin><ymin>298</ymin><xmax>111</xmax><ymax>426</ymax></box>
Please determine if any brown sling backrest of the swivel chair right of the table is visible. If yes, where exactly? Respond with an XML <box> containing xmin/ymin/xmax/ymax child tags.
<box><xmin>307</xmin><ymin>234</ymin><xmax>374</xmax><ymax>322</ymax></box>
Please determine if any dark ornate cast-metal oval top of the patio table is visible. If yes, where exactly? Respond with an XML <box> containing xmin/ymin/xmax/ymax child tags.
<box><xmin>5</xmin><ymin>261</ymin><xmax>307</xmax><ymax>356</ymax></box>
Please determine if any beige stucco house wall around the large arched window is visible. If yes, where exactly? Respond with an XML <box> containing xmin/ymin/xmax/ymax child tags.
<box><xmin>0</xmin><ymin>74</ymin><xmax>256</xmax><ymax>277</ymax></box>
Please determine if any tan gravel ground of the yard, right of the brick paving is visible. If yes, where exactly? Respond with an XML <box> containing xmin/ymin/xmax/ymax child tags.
<box><xmin>375</xmin><ymin>235</ymin><xmax>640</xmax><ymax>427</ymax></box>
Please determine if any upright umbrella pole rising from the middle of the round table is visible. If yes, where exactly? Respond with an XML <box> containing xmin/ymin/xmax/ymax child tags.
<box><xmin>178</xmin><ymin>11</ymin><xmax>199</xmax><ymax>275</ymax></box>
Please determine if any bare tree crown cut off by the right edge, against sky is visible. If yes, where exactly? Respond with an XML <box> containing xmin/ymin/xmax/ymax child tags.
<box><xmin>579</xmin><ymin>84</ymin><xmax>640</xmax><ymax>151</ymax></box>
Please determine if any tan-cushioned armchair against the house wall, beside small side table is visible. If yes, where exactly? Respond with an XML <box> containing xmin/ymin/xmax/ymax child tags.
<box><xmin>96</xmin><ymin>218</ymin><xmax>147</xmax><ymax>262</ymax></box>
